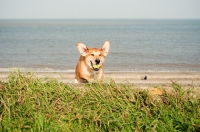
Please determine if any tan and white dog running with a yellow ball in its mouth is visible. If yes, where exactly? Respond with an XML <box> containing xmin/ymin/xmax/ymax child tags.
<box><xmin>75</xmin><ymin>41</ymin><xmax>110</xmax><ymax>83</ymax></box>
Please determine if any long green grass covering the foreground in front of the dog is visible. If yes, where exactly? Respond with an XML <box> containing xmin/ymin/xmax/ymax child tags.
<box><xmin>0</xmin><ymin>71</ymin><xmax>200</xmax><ymax>132</ymax></box>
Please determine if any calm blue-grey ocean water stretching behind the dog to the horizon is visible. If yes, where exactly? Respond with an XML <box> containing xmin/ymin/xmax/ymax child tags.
<box><xmin>0</xmin><ymin>19</ymin><xmax>200</xmax><ymax>72</ymax></box>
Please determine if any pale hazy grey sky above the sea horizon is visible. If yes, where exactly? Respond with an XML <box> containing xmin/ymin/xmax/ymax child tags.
<box><xmin>0</xmin><ymin>0</ymin><xmax>200</xmax><ymax>19</ymax></box>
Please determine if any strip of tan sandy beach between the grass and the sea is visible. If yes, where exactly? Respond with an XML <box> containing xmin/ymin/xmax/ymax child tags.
<box><xmin>0</xmin><ymin>71</ymin><xmax>200</xmax><ymax>87</ymax></box>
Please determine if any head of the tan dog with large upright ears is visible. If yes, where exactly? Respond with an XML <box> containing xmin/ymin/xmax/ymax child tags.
<box><xmin>76</xmin><ymin>41</ymin><xmax>110</xmax><ymax>71</ymax></box>
